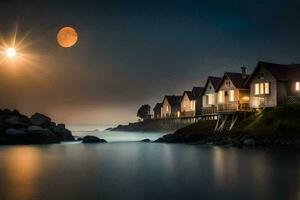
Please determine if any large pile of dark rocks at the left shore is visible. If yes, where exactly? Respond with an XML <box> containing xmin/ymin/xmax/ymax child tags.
<box><xmin>0</xmin><ymin>109</ymin><xmax>74</xmax><ymax>144</ymax></box>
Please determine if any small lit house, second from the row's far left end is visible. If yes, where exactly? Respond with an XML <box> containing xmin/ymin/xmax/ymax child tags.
<box><xmin>161</xmin><ymin>95</ymin><xmax>181</xmax><ymax>118</ymax></box>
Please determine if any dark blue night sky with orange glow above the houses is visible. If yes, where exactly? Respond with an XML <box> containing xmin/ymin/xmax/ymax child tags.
<box><xmin>0</xmin><ymin>0</ymin><xmax>300</xmax><ymax>124</ymax></box>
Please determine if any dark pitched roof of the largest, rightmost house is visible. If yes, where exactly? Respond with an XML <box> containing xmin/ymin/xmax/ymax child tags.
<box><xmin>248</xmin><ymin>61</ymin><xmax>300</xmax><ymax>82</ymax></box>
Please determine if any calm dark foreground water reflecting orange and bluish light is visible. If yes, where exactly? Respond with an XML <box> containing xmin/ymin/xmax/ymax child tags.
<box><xmin>0</xmin><ymin>129</ymin><xmax>300</xmax><ymax>200</ymax></box>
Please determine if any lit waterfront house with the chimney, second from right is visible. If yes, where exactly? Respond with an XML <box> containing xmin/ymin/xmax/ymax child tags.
<box><xmin>216</xmin><ymin>67</ymin><xmax>250</xmax><ymax>112</ymax></box>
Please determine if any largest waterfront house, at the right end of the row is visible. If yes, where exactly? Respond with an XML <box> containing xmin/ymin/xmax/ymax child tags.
<box><xmin>248</xmin><ymin>62</ymin><xmax>300</xmax><ymax>108</ymax></box>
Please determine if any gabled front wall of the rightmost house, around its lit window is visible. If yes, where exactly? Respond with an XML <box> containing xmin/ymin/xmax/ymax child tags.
<box><xmin>250</xmin><ymin>67</ymin><xmax>278</xmax><ymax>108</ymax></box>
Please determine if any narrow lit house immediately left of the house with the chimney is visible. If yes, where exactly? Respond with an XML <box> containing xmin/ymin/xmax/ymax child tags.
<box><xmin>202</xmin><ymin>76</ymin><xmax>222</xmax><ymax>114</ymax></box>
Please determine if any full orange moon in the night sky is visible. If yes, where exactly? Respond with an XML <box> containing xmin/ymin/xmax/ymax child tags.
<box><xmin>57</xmin><ymin>27</ymin><xmax>78</xmax><ymax>48</ymax></box>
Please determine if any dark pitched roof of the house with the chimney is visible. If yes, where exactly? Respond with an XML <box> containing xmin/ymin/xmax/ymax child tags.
<box><xmin>216</xmin><ymin>72</ymin><xmax>250</xmax><ymax>91</ymax></box>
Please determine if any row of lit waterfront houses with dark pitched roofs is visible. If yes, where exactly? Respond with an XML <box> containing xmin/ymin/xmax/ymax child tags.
<box><xmin>153</xmin><ymin>62</ymin><xmax>300</xmax><ymax>118</ymax></box>
